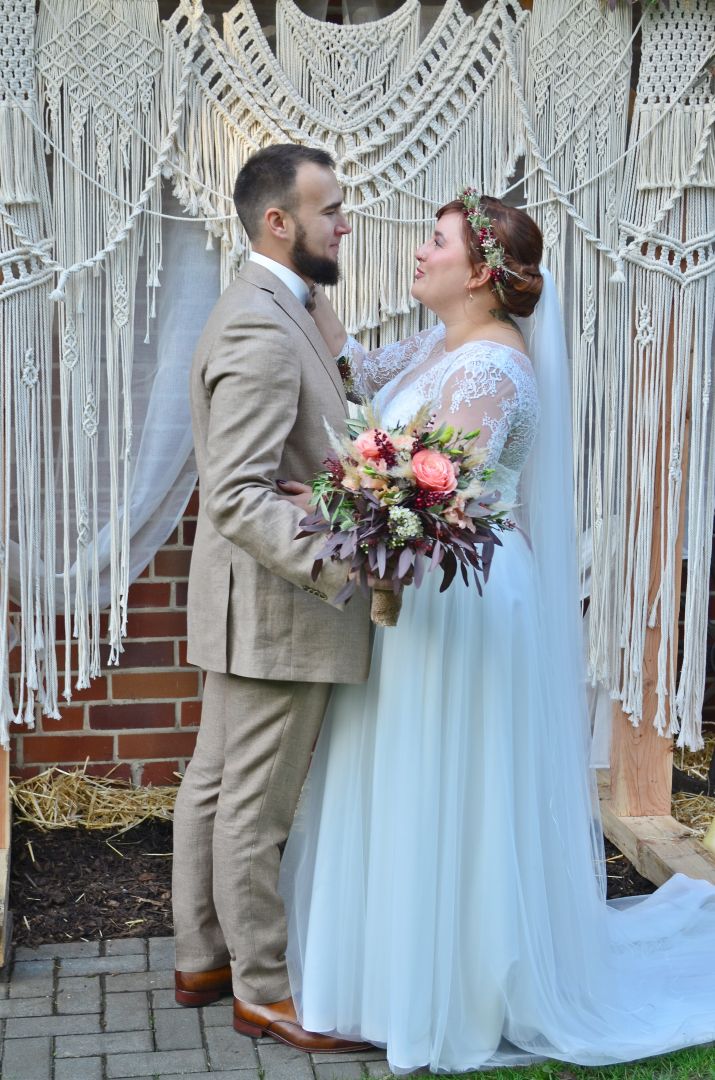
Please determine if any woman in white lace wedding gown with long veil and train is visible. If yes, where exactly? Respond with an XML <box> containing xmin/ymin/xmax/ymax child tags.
<box><xmin>281</xmin><ymin>189</ymin><xmax>715</xmax><ymax>1072</ymax></box>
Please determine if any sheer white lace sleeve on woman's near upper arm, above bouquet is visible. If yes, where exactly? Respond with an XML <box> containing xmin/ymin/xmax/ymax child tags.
<box><xmin>439</xmin><ymin>361</ymin><xmax>518</xmax><ymax>468</ymax></box>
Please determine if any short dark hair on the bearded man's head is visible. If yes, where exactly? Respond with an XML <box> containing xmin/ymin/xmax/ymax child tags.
<box><xmin>233</xmin><ymin>143</ymin><xmax>335</xmax><ymax>240</ymax></box>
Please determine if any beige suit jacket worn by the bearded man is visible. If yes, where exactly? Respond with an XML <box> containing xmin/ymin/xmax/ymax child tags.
<box><xmin>188</xmin><ymin>262</ymin><xmax>370</xmax><ymax>683</ymax></box>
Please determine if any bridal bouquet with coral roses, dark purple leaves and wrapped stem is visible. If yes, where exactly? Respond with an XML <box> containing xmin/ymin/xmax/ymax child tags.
<box><xmin>296</xmin><ymin>406</ymin><xmax>514</xmax><ymax>626</ymax></box>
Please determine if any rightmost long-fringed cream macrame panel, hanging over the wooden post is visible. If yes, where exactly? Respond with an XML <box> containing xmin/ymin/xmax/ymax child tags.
<box><xmin>605</xmin><ymin>0</ymin><xmax>715</xmax><ymax>748</ymax></box>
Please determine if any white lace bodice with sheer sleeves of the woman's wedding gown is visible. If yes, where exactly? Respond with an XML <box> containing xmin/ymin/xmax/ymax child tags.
<box><xmin>346</xmin><ymin>325</ymin><xmax>539</xmax><ymax>504</ymax></box>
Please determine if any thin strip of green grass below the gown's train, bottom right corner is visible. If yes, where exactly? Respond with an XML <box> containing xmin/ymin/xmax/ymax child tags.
<box><xmin>375</xmin><ymin>1045</ymin><xmax>715</xmax><ymax>1080</ymax></box>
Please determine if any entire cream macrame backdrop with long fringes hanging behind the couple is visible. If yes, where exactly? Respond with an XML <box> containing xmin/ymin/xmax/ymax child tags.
<box><xmin>0</xmin><ymin>0</ymin><xmax>715</xmax><ymax>747</ymax></box>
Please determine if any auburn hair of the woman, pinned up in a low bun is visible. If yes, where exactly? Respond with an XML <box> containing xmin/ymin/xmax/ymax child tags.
<box><xmin>437</xmin><ymin>195</ymin><xmax>543</xmax><ymax>318</ymax></box>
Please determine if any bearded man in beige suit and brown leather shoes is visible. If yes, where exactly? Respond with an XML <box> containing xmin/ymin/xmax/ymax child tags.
<box><xmin>173</xmin><ymin>145</ymin><xmax>369</xmax><ymax>1053</ymax></box>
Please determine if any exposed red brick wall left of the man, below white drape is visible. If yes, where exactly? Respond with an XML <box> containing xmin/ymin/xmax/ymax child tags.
<box><xmin>13</xmin><ymin>491</ymin><xmax>201</xmax><ymax>784</ymax></box>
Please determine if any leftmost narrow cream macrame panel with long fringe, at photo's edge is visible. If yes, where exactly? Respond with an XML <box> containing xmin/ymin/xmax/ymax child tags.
<box><xmin>0</xmin><ymin>0</ymin><xmax>58</xmax><ymax>746</ymax></box>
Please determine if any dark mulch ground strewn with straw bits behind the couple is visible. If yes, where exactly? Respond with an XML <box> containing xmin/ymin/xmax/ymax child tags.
<box><xmin>10</xmin><ymin>821</ymin><xmax>653</xmax><ymax>946</ymax></box>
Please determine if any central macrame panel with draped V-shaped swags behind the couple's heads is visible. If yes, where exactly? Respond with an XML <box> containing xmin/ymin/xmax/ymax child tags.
<box><xmin>164</xmin><ymin>0</ymin><xmax>526</xmax><ymax>339</ymax></box>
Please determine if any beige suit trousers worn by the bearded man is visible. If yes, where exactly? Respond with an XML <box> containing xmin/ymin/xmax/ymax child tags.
<box><xmin>173</xmin><ymin>672</ymin><xmax>330</xmax><ymax>1004</ymax></box>
